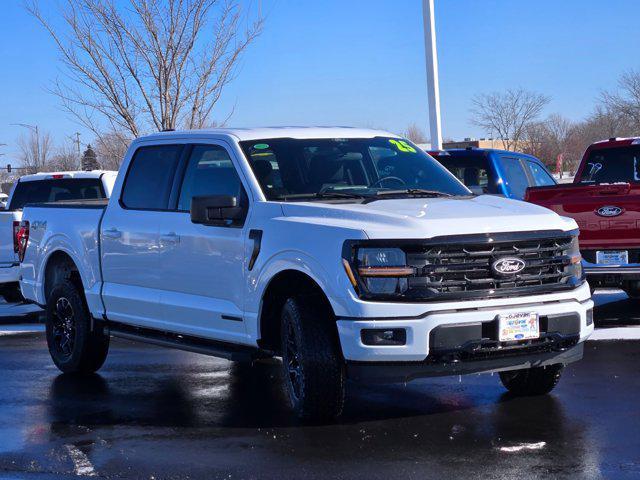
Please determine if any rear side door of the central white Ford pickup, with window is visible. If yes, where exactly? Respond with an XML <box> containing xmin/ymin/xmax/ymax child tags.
<box><xmin>100</xmin><ymin>144</ymin><xmax>184</xmax><ymax>328</ymax></box>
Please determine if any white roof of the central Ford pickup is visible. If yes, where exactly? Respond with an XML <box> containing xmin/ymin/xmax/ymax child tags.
<box><xmin>138</xmin><ymin>127</ymin><xmax>398</xmax><ymax>141</ymax></box>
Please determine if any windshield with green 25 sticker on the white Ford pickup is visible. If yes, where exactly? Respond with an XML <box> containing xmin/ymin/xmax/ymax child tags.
<box><xmin>240</xmin><ymin>137</ymin><xmax>470</xmax><ymax>201</ymax></box>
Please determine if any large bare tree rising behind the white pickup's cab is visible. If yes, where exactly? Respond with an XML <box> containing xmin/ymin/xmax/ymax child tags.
<box><xmin>28</xmin><ymin>0</ymin><xmax>262</xmax><ymax>137</ymax></box>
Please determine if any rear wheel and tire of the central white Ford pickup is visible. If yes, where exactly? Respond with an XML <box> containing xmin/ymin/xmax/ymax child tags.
<box><xmin>46</xmin><ymin>280</ymin><xmax>109</xmax><ymax>373</ymax></box>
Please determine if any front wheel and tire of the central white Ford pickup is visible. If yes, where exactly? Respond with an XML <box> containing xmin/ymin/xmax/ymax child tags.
<box><xmin>281</xmin><ymin>296</ymin><xmax>345</xmax><ymax>421</ymax></box>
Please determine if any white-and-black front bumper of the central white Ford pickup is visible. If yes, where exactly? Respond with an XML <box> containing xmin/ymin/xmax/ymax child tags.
<box><xmin>337</xmin><ymin>284</ymin><xmax>593</xmax><ymax>371</ymax></box>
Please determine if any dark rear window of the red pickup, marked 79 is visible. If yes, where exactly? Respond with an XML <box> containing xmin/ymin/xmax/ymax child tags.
<box><xmin>580</xmin><ymin>146</ymin><xmax>640</xmax><ymax>183</ymax></box>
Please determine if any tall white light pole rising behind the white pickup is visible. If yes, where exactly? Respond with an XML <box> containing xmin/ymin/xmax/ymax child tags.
<box><xmin>422</xmin><ymin>0</ymin><xmax>442</xmax><ymax>150</ymax></box>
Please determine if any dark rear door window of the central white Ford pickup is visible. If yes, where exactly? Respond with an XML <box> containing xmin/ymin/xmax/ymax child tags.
<box><xmin>121</xmin><ymin>145</ymin><xmax>183</xmax><ymax>210</ymax></box>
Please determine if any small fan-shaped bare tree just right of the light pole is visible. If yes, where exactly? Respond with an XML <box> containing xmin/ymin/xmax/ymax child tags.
<box><xmin>471</xmin><ymin>88</ymin><xmax>550</xmax><ymax>150</ymax></box>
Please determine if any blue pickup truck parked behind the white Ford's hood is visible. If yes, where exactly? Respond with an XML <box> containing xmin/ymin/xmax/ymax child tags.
<box><xmin>428</xmin><ymin>147</ymin><xmax>556</xmax><ymax>200</ymax></box>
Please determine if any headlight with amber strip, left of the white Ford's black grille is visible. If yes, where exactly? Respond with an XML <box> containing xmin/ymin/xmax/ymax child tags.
<box><xmin>355</xmin><ymin>248</ymin><xmax>415</xmax><ymax>295</ymax></box>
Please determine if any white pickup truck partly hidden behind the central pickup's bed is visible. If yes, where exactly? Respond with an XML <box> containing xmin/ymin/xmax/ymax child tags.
<box><xmin>0</xmin><ymin>170</ymin><xmax>117</xmax><ymax>302</ymax></box>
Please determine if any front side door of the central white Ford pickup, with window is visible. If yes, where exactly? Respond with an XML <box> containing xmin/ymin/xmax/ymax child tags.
<box><xmin>159</xmin><ymin>144</ymin><xmax>249</xmax><ymax>343</ymax></box>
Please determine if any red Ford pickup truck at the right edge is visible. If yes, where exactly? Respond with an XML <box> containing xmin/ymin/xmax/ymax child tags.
<box><xmin>525</xmin><ymin>137</ymin><xmax>640</xmax><ymax>298</ymax></box>
